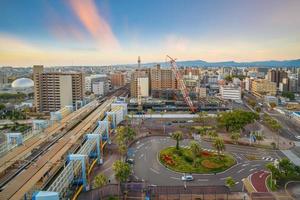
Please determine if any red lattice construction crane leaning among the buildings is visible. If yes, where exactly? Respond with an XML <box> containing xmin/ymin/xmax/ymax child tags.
<box><xmin>167</xmin><ymin>55</ymin><xmax>196</xmax><ymax>113</ymax></box>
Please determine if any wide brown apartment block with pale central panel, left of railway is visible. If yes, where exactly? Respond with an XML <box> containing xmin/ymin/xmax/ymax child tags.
<box><xmin>33</xmin><ymin>65</ymin><xmax>85</xmax><ymax>112</ymax></box>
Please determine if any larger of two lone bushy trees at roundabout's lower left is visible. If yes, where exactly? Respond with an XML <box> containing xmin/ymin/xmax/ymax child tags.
<box><xmin>113</xmin><ymin>160</ymin><xmax>131</xmax><ymax>183</ymax></box>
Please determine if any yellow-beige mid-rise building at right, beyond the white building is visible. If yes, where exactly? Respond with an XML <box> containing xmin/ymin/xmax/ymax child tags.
<box><xmin>251</xmin><ymin>79</ymin><xmax>277</xmax><ymax>98</ymax></box>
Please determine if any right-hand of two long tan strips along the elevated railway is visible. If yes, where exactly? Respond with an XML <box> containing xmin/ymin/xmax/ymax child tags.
<box><xmin>0</xmin><ymin>89</ymin><xmax>127</xmax><ymax>199</ymax></box>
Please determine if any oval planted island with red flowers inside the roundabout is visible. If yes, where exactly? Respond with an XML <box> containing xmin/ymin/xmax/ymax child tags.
<box><xmin>159</xmin><ymin>147</ymin><xmax>236</xmax><ymax>174</ymax></box>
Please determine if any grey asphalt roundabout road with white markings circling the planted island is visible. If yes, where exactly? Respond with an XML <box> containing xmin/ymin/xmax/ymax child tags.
<box><xmin>131</xmin><ymin>136</ymin><xmax>284</xmax><ymax>191</ymax></box>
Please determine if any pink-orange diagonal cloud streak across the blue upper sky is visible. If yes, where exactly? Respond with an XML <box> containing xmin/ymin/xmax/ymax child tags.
<box><xmin>69</xmin><ymin>0</ymin><xmax>120</xmax><ymax>50</ymax></box>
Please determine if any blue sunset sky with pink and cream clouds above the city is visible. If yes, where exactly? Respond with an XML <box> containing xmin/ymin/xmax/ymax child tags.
<box><xmin>0</xmin><ymin>0</ymin><xmax>300</xmax><ymax>66</ymax></box>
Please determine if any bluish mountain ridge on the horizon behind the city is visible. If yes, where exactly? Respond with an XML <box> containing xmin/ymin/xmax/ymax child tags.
<box><xmin>137</xmin><ymin>59</ymin><xmax>300</xmax><ymax>67</ymax></box>
